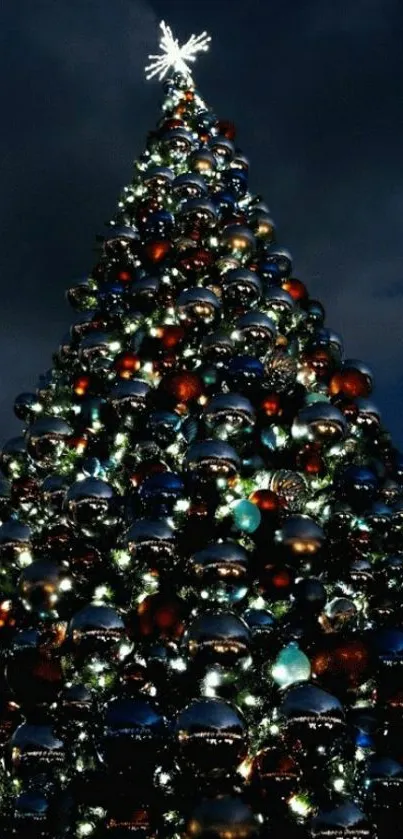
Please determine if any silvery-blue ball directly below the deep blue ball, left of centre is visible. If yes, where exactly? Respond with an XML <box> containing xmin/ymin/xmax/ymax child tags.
<box><xmin>125</xmin><ymin>519</ymin><xmax>176</xmax><ymax>569</ymax></box>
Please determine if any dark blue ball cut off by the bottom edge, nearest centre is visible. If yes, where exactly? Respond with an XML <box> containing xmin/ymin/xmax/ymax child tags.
<box><xmin>184</xmin><ymin>795</ymin><xmax>259</xmax><ymax>839</ymax></box>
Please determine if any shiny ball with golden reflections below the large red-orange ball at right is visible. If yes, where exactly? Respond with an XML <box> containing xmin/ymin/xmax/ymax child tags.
<box><xmin>291</xmin><ymin>402</ymin><xmax>348</xmax><ymax>446</ymax></box>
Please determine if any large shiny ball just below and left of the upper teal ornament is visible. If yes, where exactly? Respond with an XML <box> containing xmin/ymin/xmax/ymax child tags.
<box><xmin>188</xmin><ymin>542</ymin><xmax>249</xmax><ymax>604</ymax></box>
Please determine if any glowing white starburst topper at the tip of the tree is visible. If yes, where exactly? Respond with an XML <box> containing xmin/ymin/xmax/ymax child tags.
<box><xmin>145</xmin><ymin>20</ymin><xmax>215</xmax><ymax>81</ymax></box>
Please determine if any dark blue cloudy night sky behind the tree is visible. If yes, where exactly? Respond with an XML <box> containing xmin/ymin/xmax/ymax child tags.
<box><xmin>0</xmin><ymin>0</ymin><xmax>403</xmax><ymax>445</ymax></box>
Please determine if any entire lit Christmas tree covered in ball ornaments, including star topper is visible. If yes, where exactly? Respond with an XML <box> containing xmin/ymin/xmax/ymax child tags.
<box><xmin>0</xmin><ymin>19</ymin><xmax>403</xmax><ymax>839</ymax></box>
